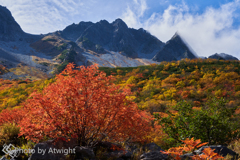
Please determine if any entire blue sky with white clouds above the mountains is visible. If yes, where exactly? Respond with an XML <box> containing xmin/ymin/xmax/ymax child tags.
<box><xmin>0</xmin><ymin>0</ymin><xmax>240</xmax><ymax>58</ymax></box>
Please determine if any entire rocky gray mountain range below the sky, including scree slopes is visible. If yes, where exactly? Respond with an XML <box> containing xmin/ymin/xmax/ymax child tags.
<box><xmin>0</xmin><ymin>6</ymin><xmax>238</xmax><ymax>79</ymax></box>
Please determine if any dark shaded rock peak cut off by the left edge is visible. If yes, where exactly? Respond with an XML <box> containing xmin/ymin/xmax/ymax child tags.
<box><xmin>0</xmin><ymin>5</ymin><xmax>24</xmax><ymax>41</ymax></box>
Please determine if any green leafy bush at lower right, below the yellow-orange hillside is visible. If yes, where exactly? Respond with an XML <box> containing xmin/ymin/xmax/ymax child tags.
<box><xmin>155</xmin><ymin>99</ymin><xmax>240</xmax><ymax>145</ymax></box>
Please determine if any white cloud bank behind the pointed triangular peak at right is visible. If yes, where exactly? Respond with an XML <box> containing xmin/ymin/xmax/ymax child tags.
<box><xmin>123</xmin><ymin>0</ymin><xmax>240</xmax><ymax>58</ymax></box>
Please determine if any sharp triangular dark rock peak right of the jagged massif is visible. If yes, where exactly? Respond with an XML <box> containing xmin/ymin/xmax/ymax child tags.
<box><xmin>153</xmin><ymin>33</ymin><xmax>197</xmax><ymax>62</ymax></box>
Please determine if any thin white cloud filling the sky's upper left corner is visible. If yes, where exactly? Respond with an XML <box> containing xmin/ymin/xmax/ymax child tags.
<box><xmin>0</xmin><ymin>0</ymin><xmax>91</xmax><ymax>34</ymax></box>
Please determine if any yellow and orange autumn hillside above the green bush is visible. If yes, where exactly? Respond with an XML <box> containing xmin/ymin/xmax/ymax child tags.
<box><xmin>100</xmin><ymin>59</ymin><xmax>240</xmax><ymax>113</ymax></box>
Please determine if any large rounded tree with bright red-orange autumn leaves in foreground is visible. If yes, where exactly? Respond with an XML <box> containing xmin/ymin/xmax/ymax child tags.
<box><xmin>20</xmin><ymin>64</ymin><xmax>151</xmax><ymax>146</ymax></box>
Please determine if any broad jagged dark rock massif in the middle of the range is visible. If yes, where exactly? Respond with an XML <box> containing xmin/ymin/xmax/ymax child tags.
<box><xmin>61</xmin><ymin>19</ymin><xmax>164</xmax><ymax>59</ymax></box>
